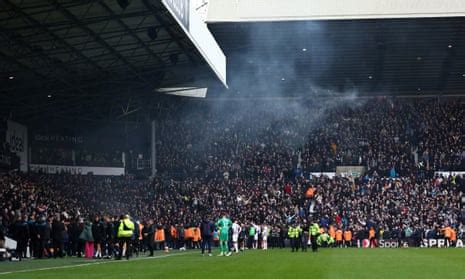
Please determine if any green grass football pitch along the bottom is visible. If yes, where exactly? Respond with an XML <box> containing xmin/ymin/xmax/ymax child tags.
<box><xmin>0</xmin><ymin>248</ymin><xmax>465</xmax><ymax>279</ymax></box>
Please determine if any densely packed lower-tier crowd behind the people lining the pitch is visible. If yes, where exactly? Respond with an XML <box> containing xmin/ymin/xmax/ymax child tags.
<box><xmin>0</xmin><ymin>174</ymin><xmax>465</xmax><ymax>256</ymax></box>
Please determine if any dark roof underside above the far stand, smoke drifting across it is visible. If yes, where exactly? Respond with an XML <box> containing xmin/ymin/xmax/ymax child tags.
<box><xmin>209</xmin><ymin>17</ymin><xmax>465</xmax><ymax>96</ymax></box>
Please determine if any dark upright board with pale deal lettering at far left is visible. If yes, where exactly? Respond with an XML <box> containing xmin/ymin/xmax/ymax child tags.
<box><xmin>6</xmin><ymin>120</ymin><xmax>29</xmax><ymax>172</ymax></box>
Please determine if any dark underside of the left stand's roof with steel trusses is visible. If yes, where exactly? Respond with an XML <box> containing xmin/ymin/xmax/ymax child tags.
<box><xmin>0</xmin><ymin>0</ymin><xmax>218</xmax><ymax>122</ymax></box>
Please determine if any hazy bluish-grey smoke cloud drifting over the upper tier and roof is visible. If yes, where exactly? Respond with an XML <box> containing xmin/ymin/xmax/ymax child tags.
<box><xmin>158</xmin><ymin>22</ymin><xmax>364</xmax><ymax>177</ymax></box>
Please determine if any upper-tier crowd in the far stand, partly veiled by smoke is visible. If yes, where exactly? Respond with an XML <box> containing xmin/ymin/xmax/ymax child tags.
<box><xmin>157</xmin><ymin>99</ymin><xmax>465</xmax><ymax>175</ymax></box>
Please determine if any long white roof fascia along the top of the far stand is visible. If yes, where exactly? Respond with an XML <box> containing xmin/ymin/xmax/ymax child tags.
<box><xmin>207</xmin><ymin>0</ymin><xmax>465</xmax><ymax>23</ymax></box>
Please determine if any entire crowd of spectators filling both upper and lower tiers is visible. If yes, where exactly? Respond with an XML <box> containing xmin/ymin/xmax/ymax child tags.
<box><xmin>0</xmin><ymin>99</ymin><xmax>465</xmax><ymax>260</ymax></box>
